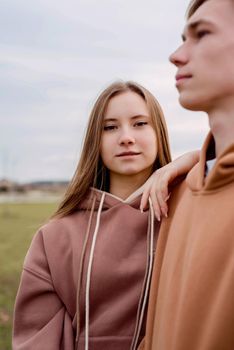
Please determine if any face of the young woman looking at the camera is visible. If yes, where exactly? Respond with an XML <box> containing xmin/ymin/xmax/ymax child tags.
<box><xmin>100</xmin><ymin>91</ymin><xmax>157</xmax><ymax>186</ymax></box>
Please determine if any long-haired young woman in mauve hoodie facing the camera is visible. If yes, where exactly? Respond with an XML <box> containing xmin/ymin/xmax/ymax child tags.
<box><xmin>13</xmin><ymin>82</ymin><xmax>198</xmax><ymax>350</ymax></box>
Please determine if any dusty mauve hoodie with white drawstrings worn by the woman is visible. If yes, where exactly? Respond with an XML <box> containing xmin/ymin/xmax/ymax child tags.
<box><xmin>13</xmin><ymin>188</ymin><xmax>159</xmax><ymax>350</ymax></box>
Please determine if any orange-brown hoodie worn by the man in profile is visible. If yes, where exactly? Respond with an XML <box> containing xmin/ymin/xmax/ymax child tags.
<box><xmin>140</xmin><ymin>135</ymin><xmax>234</xmax><ymax>350</ymax></box>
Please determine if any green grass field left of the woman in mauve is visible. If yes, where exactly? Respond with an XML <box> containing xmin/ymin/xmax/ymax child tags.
<box><xmin>0</xmin><ymin>203</ymin><xmax>56</xmax><ymax>350</ymax></box>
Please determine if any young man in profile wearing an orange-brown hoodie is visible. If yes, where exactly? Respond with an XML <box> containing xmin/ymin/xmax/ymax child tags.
<box><xmin>140</xmin><ymin>0</ymin><xmax>234</xmax><ymax>350</ymax></box>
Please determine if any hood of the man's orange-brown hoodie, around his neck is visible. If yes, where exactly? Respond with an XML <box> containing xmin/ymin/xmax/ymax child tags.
<box><xmin>186</xmin><ymin>133</ymin><xmax>234</xmax><ymax>193</ymax></box>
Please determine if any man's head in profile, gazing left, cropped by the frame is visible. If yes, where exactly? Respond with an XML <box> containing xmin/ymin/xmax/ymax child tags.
<box><xmin>170</xmin><ymin>0</ymin><xmax>234</xmax><ymax>113</ymax></box>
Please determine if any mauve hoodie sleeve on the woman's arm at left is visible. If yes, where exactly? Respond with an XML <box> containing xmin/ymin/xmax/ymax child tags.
<box><xmin>12</xmin><ymin>231</ymin><xmax>74</xmax><ymax>350</ymax></box>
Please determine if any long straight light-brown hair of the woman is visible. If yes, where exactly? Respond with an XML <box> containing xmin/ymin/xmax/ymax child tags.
<box><xmin>53</xmin><ymin>81</ymin><xmax>171</xmax><ymax>217</ymax></box>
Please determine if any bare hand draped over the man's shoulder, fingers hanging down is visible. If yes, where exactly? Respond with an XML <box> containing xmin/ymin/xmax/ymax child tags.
<box><xmin>140</xmin><ymin>151</ymin><xmax>200</xmax><ymax>221</ymax></box>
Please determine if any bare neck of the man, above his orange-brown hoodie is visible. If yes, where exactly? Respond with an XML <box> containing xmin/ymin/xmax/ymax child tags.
<box><xmin>209</xmin><ymin>109</ymin><xmax>234</xmax><ymax>157</ymax></box>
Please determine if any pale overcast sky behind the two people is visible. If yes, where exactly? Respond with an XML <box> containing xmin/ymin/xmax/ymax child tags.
<box><xmin>0</xmin><ymin>0</ymin><xmax>208</xmax><ymax>182</ymax></box>
